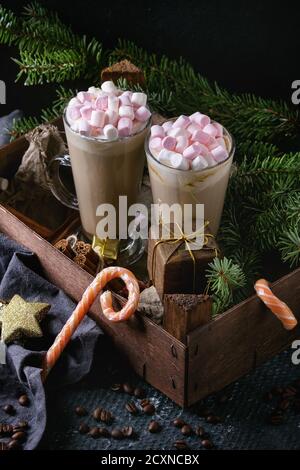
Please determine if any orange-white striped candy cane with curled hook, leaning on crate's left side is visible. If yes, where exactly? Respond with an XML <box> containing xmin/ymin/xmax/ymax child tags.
<box><xmin>42</xmin><ymin>267</ymin><xmax>140</xmax><ymax>381</ymax></box>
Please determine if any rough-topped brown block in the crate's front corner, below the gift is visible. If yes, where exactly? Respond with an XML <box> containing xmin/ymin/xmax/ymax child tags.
<box><xmin>163</xmin><ymin>294</ymin><xmax>212</xmax><ymax>343</ymax></box>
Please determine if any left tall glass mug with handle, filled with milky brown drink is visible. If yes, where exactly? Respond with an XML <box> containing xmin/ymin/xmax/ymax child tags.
<box><xmin>52</xmin><ymin>112</ymin><xmax>151</xmax><ymax>264</ymax></box>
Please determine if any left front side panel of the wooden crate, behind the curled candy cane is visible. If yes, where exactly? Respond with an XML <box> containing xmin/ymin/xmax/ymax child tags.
<box><xmin>0</xmin><ymin>205</ymin><xmax>186</xmax><ymax>406</ymax></box>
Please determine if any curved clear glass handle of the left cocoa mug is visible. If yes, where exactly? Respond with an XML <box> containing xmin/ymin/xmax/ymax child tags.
<box><xmin>48</xmin><ymin>155</ymin><xmax>79</xmax><ymax>210</ymax></box>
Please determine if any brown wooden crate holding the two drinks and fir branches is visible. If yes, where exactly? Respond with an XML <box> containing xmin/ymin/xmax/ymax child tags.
<box><xmin>0</xmin><ymin>126</ymin><xmax>300</xmax><ymax>407</ymax></box>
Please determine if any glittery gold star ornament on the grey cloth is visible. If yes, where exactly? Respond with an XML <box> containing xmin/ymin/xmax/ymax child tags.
<box><xmin>0</xmin><ymin>295</ymin><xmax>50</xmax><ymax>344</ymax></box>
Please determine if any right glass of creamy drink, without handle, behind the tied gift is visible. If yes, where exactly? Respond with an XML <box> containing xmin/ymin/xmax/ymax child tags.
<box><xmin>145</xmin><ymin>124</ymin><xmax>235</xmax><ymax>235</ymax></box>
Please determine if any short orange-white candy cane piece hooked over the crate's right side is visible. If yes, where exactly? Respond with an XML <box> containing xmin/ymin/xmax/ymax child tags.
<box><xmin>254</xmin><ymin>279</ymin><xmax>298</xmax><ymax>330</ymax></box>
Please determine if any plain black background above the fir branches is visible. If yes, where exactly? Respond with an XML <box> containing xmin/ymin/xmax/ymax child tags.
<box><xmin>0</xmin><ymin>0</ymin><xmax>300</xmax><ymax>115</ymax></box>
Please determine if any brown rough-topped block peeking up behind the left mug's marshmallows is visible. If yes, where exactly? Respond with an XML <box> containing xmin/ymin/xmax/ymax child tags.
<box><xmin>101</xmin><ymin>59</ymin><xmax>145</xmax><ymax>85</ymax></box>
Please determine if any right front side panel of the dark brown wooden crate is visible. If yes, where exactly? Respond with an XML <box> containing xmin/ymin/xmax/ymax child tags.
<box><xmin>187</xmin><ymin>269</ymin><xmax>300</xmax><ymax>405</ymax></box>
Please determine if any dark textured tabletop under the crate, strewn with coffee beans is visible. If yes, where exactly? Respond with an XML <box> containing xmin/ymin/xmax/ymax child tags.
<box><xmin>41</xmin><ymin>341</ymin><xmax>300</xmax><ymax>450</ymax></box>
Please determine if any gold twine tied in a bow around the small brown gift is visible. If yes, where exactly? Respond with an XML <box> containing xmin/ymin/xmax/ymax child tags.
<box><xmin>151</xmin><ymin>221</ymin><xmax>218</xmax><ymax>292</ymax></box>
